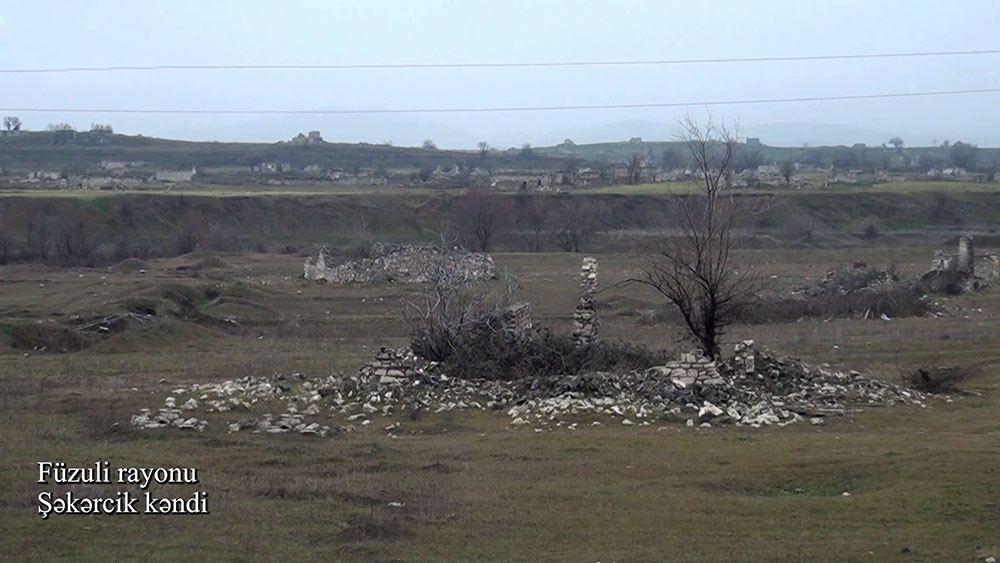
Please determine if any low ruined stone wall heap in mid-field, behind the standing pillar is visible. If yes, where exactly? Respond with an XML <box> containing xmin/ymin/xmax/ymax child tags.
<box><xmin>303</xmin><ymin>243</ymin><xmax>496</xmax><ymax>285</ymax></box>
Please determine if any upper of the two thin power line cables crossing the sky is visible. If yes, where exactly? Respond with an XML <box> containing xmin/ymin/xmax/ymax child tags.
<box><xmin>0</xmin><ymin>49</ymin><xmax>1000</xmax><ymax>74</ymax></box>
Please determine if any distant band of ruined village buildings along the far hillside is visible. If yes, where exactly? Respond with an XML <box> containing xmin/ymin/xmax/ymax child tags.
<box><xmin>7</xmin><ymin>130</ymin><xmax>1000</xmax><ymax>192</ymax></box>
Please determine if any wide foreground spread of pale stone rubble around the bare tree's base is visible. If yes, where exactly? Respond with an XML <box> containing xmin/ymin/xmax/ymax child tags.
<box><xmin>132</xmin><ymin>341</ymin><xmax>926</xmax><ymax>436</ymax></box>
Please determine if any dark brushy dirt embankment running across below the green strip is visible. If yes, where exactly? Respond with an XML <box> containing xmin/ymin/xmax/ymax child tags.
<box><xmin>0</xmin><ymin>192</ymin><xmax>1000</xmax><ymax>262</ymax></box>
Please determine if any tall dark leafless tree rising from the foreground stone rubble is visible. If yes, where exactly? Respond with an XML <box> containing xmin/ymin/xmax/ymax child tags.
<box><xmin>630</xmin><ymin>118</ymin><xmax>757</xmax><ymax>358</ymax></box>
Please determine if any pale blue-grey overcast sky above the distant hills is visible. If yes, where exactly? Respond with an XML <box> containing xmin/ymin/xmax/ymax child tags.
<box><xmin>0</xmin><ymin>0</ymin><xmax>1000</xmax><ymax>148</ymax></box>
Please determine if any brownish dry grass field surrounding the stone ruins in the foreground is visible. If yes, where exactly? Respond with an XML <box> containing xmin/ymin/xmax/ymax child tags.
<box><xmin>0</xmin><ymin>247</ymin><xmax>1000</xmax><ymax>561</ymax></box>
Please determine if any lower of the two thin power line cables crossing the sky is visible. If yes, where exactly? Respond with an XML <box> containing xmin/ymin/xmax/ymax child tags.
<box><xmin>0</xmin><ymin>88</ymin><xmax>1000</xmax><ymax>115</ymax></box>
